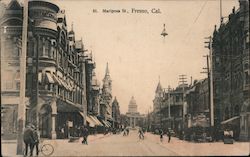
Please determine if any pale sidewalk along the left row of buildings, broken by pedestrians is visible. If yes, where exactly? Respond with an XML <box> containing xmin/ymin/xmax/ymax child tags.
<box><xmin>1</xmin><ymin>134</ymin><xmax>110</xmax><ymax>157</ymax></box>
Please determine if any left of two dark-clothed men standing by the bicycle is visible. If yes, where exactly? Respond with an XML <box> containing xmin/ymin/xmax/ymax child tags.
<box><xmin>23</xmin><ymin>124</ymin><xmax>35</xmax><ymax>156</ymax></box>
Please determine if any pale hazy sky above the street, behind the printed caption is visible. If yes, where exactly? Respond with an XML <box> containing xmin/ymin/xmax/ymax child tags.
<box><xmin>2</xmin><ymin>0</ymin><xmax>239</xmax><ymax>113</ymax></box>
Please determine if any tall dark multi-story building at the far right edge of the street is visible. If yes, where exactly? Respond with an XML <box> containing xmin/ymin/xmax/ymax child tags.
<box><xmin>212</xmin><ymin>0</ymin><xmax>250</xmax><ymax>140</ymax></box>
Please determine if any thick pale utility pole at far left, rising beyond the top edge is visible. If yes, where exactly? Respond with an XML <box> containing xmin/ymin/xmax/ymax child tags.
<box><xmin>17</xmin><ymin>0</ymin><xmax>28</xmax><ymax>155</ymax></box>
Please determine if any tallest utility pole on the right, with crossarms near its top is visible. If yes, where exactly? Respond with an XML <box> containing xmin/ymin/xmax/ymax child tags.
<box><xmin>205</xmin><ymin>36</ymin><xmax>214</xmax><ymax>127</ymax></box>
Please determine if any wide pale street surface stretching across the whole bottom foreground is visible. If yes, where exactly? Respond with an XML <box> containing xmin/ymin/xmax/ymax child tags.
<box><xmin>2</xmin><ymin>130</ymin><xmax>250</xmax><ymax>156</ymax></box>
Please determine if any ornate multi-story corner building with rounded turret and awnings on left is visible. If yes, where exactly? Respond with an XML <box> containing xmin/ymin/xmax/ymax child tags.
<box><xmin>1</xmin><ymin>0</ymin><xmax>88</xmax><ymax>138</ymax></box>
